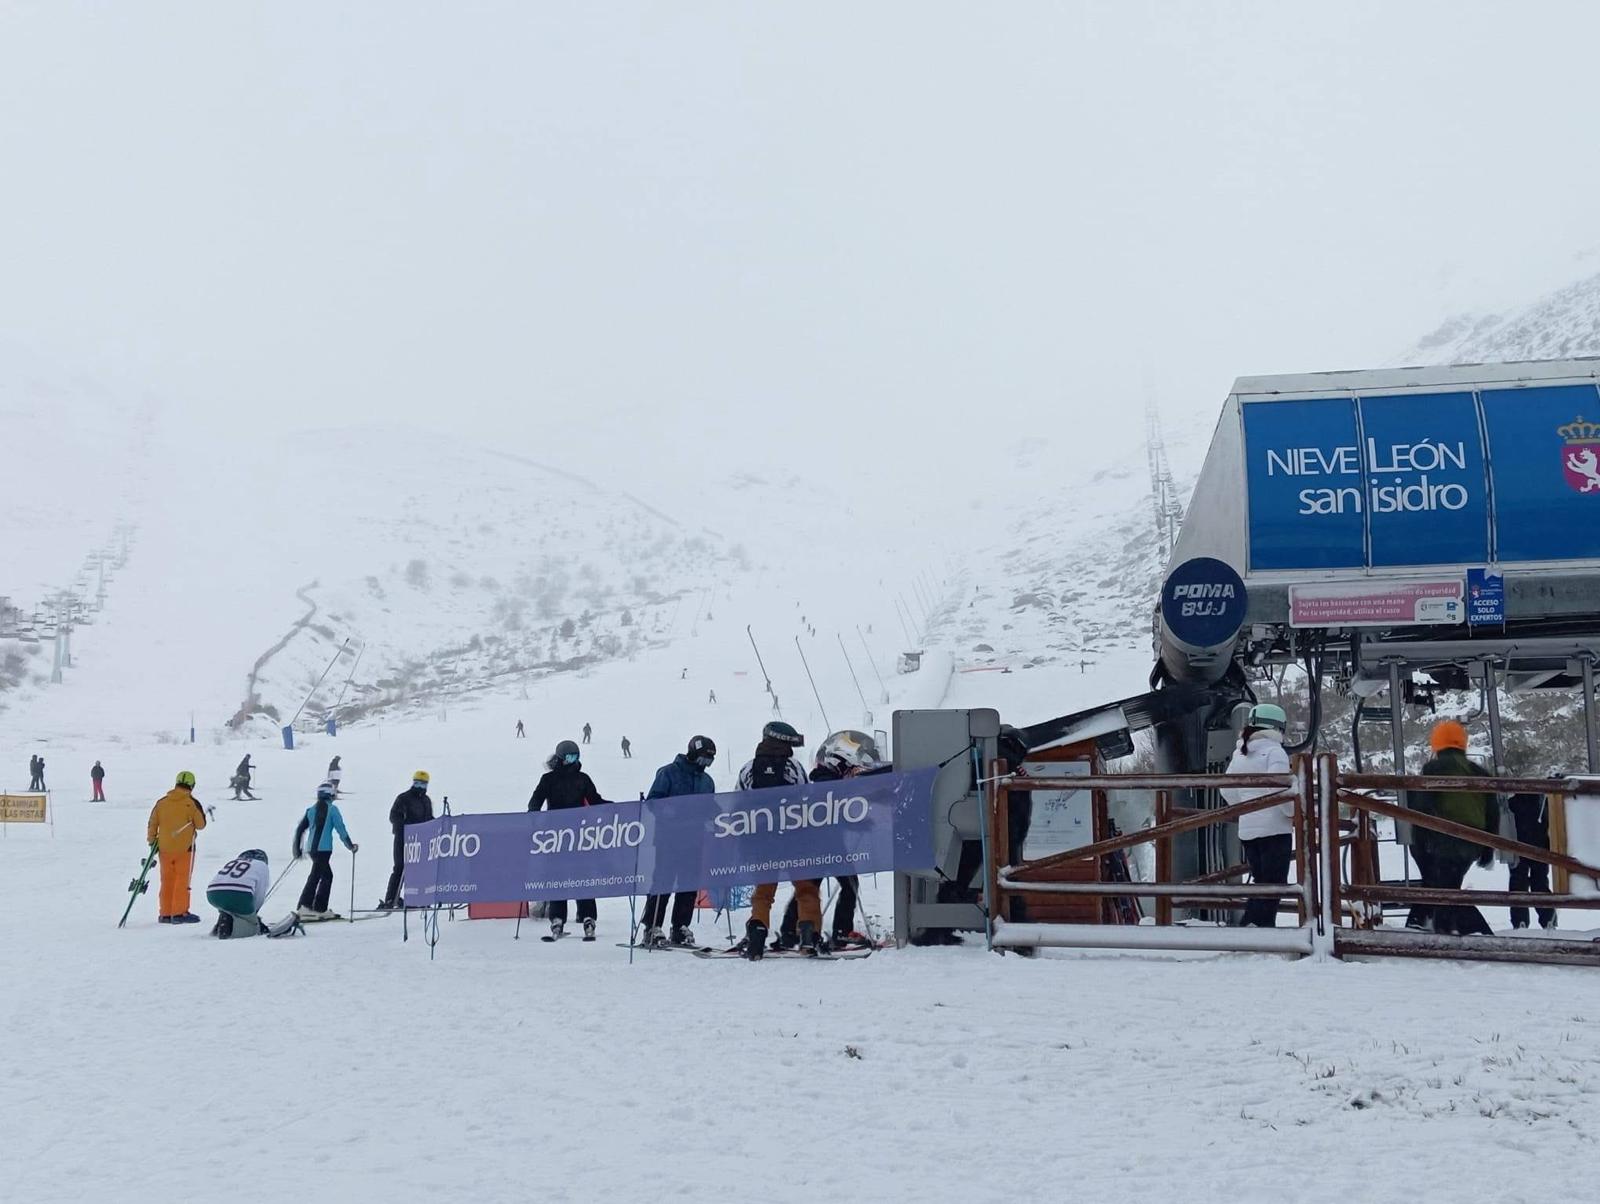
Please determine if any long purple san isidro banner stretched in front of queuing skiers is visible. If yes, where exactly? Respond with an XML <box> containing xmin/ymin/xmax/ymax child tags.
<box><xmin>396</xmin><ymin>769</ymin><xmax>936</xmax><ymax>906</ymax></box>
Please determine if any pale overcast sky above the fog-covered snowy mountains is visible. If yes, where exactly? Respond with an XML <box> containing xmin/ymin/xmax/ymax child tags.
<box><xmin>0</xmin><ymin>0</ymin><xmax>1600</xmax><ymax>509</ymax></box>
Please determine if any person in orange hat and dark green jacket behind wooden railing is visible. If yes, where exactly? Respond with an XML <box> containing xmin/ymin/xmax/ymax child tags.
<box><xmin>1405</xmin><ymin>719</ymin><xmax>1499</xmax><ymax>937</ymax></box>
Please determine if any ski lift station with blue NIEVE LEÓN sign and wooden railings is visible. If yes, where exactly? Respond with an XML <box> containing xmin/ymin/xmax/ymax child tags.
<box><xmin>894</xmin><ymin>359</ymin><xmax>1600</xmax><ymax>961</ymax></box>
